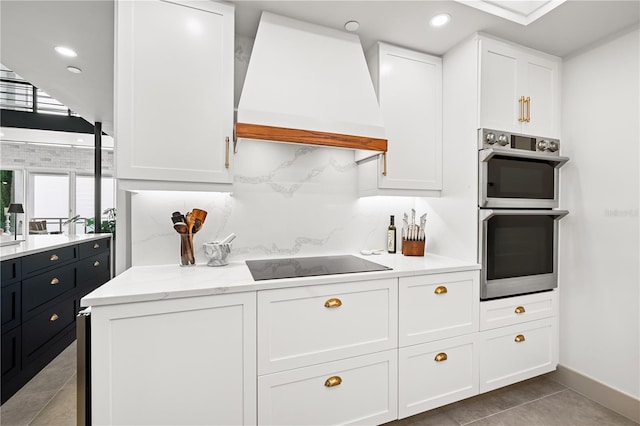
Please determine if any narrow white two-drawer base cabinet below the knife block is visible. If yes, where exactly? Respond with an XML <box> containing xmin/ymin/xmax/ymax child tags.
<box><xmin>398</xmin><ymin>271</ymin><xmax>479</xmax><ymax>418</ymax></box>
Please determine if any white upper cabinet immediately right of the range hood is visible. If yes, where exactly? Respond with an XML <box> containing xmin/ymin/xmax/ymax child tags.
<box><xmin>356</xmin><ymin>43</ymin><xmax>442</xmax><ymax>195</ymax></box>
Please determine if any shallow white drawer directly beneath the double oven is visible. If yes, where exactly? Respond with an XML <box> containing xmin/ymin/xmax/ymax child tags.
<box><xmin>480</xmin><ymin>290</ymin><xmax>558</xmax><ymax>330</ymax></box>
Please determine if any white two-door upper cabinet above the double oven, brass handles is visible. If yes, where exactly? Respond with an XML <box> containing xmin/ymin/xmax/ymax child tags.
<box><xmin>479</xmin><ymin>38</ymin><xmax>560</xmax><ymax>137</ymax></box>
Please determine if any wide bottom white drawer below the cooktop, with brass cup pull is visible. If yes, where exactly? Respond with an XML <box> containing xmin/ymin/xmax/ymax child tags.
<box><xmin>258</xmin><ymin>350</ymin><xmax>398</xmax><ymax>426</ymax></box>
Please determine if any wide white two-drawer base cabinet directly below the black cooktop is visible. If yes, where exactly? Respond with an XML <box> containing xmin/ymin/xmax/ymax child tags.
<box><xmin>258</xmin><ymin>279</ymin><xmax>398</xmax><ymax>425</ymax></box>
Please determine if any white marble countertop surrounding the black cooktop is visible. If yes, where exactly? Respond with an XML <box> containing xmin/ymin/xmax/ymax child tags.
<box><xmin>81</xmin><ymin>254</ymin><xmax>480</xmax><ymax>307</ymax></box>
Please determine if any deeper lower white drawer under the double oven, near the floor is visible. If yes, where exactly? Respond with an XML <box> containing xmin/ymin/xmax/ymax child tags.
<box><xmin>480</xmin><ymin>318</ymin><xmax>558</xmax><ymax>392</ymax></box>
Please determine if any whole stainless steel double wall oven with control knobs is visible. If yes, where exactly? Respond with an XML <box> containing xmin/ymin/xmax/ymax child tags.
<box><xmin>478</xmin><ymin>129</ymin><xmax>569</xmax><ymax>300</ymax></box>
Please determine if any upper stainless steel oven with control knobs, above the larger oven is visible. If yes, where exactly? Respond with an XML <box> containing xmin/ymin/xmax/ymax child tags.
<box><xmin>478</xmin><ymin>129</ymin><xmax>569</xmax><ymax>208</ymax></box>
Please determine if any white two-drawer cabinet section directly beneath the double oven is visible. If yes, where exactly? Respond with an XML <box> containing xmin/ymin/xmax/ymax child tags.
<box><xmin>480</xmin><ymin>291</ymin><xmax>558</xmax><ymax>392</ymax></box>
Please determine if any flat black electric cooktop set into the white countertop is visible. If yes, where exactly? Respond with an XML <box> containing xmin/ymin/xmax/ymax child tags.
<box><xmin>245</xmin><ymin>255</ymin><xmax>392</xmax><ymax>281</ymax></box>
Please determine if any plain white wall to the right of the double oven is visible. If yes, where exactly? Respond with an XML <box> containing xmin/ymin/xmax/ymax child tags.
<box><xmin>559</xmin><ymin>29</ymin><xmax>640</xmax><ymax>398</ymax></box>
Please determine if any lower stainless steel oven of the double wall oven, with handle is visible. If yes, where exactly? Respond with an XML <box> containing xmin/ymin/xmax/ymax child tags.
<box><xmin>479</xmin><ymin>209</ymin><xmax>569</xmax><ymax>300</ymax></box>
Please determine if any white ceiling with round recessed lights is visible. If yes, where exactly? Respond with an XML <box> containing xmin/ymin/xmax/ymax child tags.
<box><xmin>0</xmin><ymin>0</ymin><xmax>640</xmax><ymax>145</ymax></box>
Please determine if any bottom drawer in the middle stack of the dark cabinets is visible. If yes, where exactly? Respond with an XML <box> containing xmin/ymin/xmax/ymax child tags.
<box><xmin>22</xmin><ymin>298</ymin><xmax>76</xmax><ymax>364</ymax></box>
